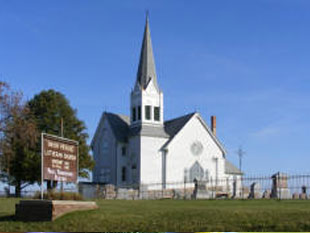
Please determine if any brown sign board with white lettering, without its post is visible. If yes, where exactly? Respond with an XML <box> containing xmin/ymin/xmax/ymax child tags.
<box><xmin>42</xmin><ymin>134</ymin><xmax>78</xmax><ymax>182</ymax></box>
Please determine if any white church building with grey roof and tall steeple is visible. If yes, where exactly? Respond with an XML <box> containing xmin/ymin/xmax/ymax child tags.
<box><xmin>91</xmin><ymin>16</ymin><xmax>242</xmax><ymax>195</ymax></box>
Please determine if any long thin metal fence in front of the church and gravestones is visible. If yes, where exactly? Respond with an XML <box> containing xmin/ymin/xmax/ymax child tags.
<box><xmin>79</xmin><ymin>173</ymin><xmax>310</xmax><ymax>200</ymax></box>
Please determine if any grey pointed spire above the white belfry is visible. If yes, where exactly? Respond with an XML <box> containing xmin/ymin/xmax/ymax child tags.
<box><xmin>136</xmin><ymin>11</ymin><xmax>159</xmax><ymax>91</ymax></box>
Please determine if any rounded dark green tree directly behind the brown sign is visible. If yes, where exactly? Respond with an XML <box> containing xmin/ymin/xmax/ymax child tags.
<box><xmin>28</xmin><ymin>90</ymin><xmax>94</xmax><ymax>186</ymax></box>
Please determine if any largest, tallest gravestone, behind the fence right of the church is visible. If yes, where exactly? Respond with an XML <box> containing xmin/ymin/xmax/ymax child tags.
<box><xmin>271</xmin><ymin>172</ymin><xmax>291</xmax><ymax>199</ymax></box>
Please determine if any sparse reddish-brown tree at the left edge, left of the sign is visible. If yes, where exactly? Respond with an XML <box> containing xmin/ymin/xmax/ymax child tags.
<box><xmin>0</xmin><ymin>82</ymin><xmax>40</xmax><ymax>196</ymax></box>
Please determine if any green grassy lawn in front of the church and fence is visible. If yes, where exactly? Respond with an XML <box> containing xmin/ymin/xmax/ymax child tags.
<box><xmin>0</xmin><ymin>198</ymin><xmax>310</xmax><ymax>232</ymax></box>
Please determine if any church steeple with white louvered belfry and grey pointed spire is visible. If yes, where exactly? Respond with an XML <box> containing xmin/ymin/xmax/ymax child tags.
<box><xmin>130</xmin><ymin>15</ymin><xmax>167</xmax><ymax>137</ymax></box>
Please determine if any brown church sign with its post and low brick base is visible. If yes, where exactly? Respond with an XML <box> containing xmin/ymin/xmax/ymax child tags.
<box><xmin>15</xmin><ymin>133</ymin><xmax>98</xmax><ymax>221</ymax></box>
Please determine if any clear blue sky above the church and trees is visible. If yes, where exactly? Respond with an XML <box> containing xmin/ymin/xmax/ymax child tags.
<box><xmin>0</xmin><ymin>0</ymin><xmax>310</xmax><ymax>174</ymax></box>
